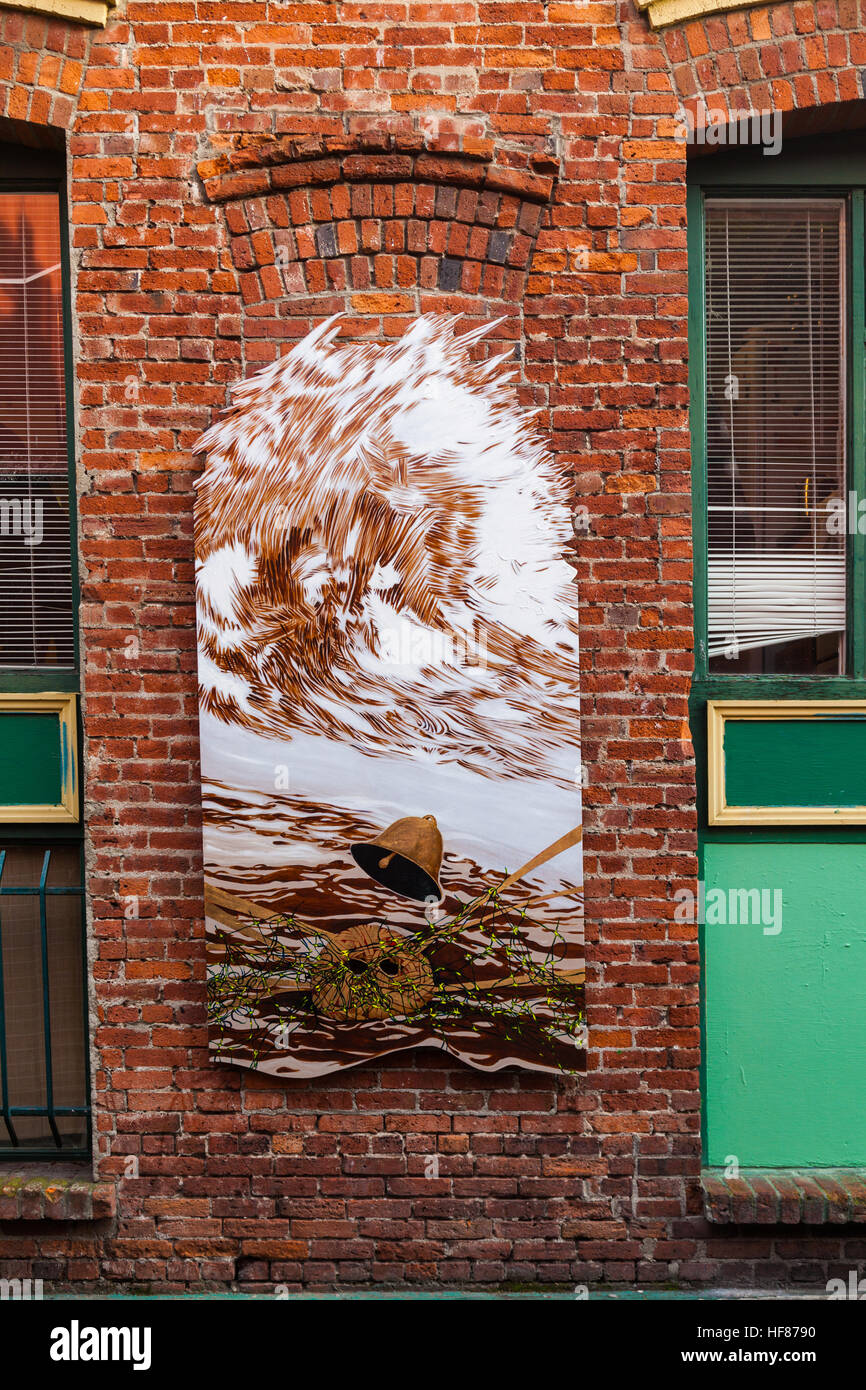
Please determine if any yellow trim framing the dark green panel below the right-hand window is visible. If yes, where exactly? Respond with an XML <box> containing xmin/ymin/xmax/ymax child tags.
<box><xmin>706</xmin><ymin>699</ymin><xmax>866</xmax><ymax>826</ymax></box>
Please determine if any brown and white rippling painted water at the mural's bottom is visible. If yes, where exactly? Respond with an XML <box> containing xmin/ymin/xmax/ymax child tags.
<box><xmin>204</xmin><ymin>783</ymin><xmax>585</xmax><ymax>1076</ymax></box>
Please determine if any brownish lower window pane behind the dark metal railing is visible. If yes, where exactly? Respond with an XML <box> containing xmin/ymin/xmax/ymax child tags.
<box><xmin>0</xmin><ymin>845</ymin><xmax>88</xmax><ymax>1158</ymax></box>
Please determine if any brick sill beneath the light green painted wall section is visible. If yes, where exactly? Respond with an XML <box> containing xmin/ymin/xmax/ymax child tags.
<box><xmin>701</xmin><ymin>1168</ymin><xmax>866</xmax><ymax>1226</ymax></box>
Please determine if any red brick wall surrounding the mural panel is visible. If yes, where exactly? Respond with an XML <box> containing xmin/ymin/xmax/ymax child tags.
<box><xmin>0</xmin><ymin>0</ymin><xmax>866</xmax><ymax>1286</ymax></box>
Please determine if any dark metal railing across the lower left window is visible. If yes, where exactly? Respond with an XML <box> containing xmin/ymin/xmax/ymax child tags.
<box><xmin>0</xmin><ymin>849</ymin><xmax>90</xmax><ymax>1158</ymax></box>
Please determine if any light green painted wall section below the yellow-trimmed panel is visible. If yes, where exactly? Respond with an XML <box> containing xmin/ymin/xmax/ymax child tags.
<box><xmin>703</xmin><ymin>840</ymin><xmax>866</xmax><ymax>1168</ymax></box>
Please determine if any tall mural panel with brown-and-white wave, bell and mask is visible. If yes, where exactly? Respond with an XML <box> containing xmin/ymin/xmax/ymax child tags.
<box><xmin>196</xmin><ymin>316</ymin><xmax>585</xmax><ymax>1077</ymax></box>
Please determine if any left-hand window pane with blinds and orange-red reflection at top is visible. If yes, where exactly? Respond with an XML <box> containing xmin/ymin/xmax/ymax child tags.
<box><xmin>0</xmin><ymin>192</ymin><xmax>75</xmax><ymax>669</ymax></box>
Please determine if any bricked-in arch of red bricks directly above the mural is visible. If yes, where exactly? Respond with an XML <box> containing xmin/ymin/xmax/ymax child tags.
<box><xmin>199</xmin><ymin>136</ymin><xmax>557</xmax><ymax>366</ymax></box>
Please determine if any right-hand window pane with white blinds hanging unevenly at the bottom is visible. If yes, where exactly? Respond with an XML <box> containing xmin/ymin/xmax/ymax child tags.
<box><xmin>706</xmin><ymin>199</ymin><xmax>847</xmax><ymax>674</ymax></box>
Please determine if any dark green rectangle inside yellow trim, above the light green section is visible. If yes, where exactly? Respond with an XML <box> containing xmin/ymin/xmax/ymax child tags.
<box><xmin>724</xmin><ymin>713</ymin><xmax>866</xmax><ymax>806</ymax></box>
